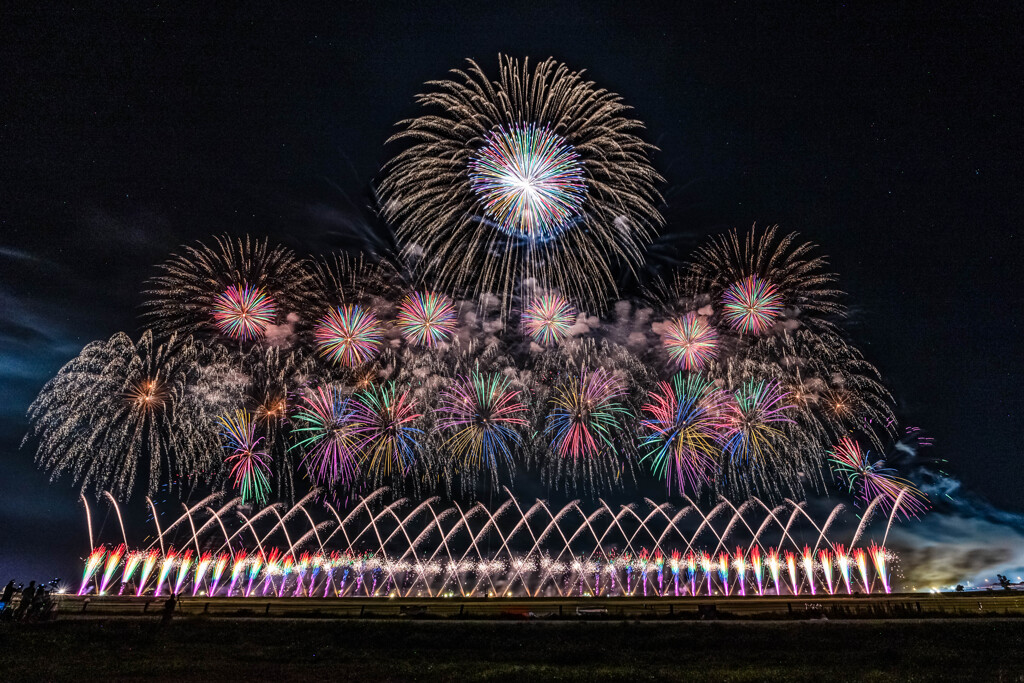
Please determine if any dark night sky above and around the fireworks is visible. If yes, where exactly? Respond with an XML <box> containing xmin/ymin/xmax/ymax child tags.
<box><xmin>0</xmin><ymin>1</ymin><xmax>1024</xmax><ymax>575</ymax></box>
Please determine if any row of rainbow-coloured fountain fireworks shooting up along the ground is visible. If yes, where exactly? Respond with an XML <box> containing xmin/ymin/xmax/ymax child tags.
<box><xmin>79</xmin><ymin>545</ymin><xmax>890</xmax><ymax>597</ymax></box>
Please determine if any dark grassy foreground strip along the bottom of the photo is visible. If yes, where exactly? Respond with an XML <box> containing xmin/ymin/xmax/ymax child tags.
<box><xmin>0</xmin><ymin>616</ymin><xmax>1024</xmax><ymax>682</ymax></box>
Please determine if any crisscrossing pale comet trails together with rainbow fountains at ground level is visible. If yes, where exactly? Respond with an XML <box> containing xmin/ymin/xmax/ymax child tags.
<box><xmin>80</xmin><ymin>490</ymin><xmax>897</xmax><ymax>598</ymax></box>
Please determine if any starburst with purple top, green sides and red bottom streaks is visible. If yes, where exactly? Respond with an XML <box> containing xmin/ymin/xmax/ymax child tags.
<box><xmin>544</xmin><ymin>369</ymin><xmax>628</xmax><ymax>460</ymax></box>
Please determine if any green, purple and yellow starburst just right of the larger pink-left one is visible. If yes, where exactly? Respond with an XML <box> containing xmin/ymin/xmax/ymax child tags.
<box><xmin>721</xmin><ymin>380</ymin><xmax>793</xmax><ymax>463</ymax></box>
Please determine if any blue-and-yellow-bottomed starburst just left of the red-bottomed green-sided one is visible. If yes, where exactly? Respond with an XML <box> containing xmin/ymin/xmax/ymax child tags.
<box><xmin>437</xmin><ymin>373</ymin><xmax>528</xmax><ymax>469</ymax></box>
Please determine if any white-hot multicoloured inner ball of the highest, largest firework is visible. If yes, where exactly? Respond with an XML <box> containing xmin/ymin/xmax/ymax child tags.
<box><xmin>469</xmin><ymin>124</ymin><xmax>587</xmax><ymax>241</ymax></box>
